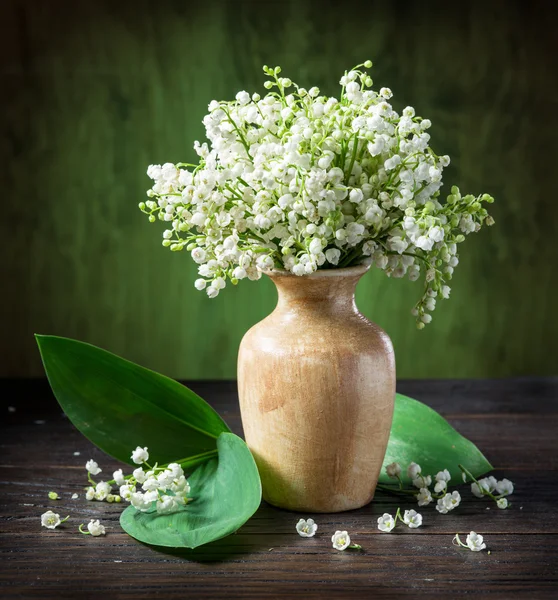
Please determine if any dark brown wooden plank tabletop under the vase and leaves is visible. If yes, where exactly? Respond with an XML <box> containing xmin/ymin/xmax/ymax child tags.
<box><xmin>0</xmin><ymin>378</ymin><xmax>558</xmax><ymax>599</ymax></box>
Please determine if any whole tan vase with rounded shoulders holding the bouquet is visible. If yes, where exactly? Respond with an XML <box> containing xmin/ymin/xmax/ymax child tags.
<box><xmin>238</xmin><ymin>266</ymin><xmax>395</xmax><ymax>512</ymax></box>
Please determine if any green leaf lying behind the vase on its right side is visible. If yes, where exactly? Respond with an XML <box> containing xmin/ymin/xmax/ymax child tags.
<box><xmin>379</xmin><ymin>394</ymin><xmax>493</xmax><ymax>484</ymax></box>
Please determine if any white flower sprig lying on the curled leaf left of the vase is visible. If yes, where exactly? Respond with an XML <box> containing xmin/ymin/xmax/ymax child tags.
<box><xmin>114</xmin><ymin>446</ymin><xmax>190</xmax><ymax>514</ymax></box>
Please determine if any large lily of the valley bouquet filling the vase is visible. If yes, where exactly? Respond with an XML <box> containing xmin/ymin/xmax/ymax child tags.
<box><xmin>140</xmin><ymin>61</ymin><xmax>494</xmax><ymax>328</ymax></box>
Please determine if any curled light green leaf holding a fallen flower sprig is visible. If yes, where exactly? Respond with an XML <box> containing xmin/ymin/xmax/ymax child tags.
<box><xmin>120</xmin><ymin>433</ymin><xmax>262</xmax><ymax>548</ymax></box>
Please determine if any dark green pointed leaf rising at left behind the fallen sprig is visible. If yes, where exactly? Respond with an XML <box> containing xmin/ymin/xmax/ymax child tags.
<box><xmin>36</xmin><ymin>335</ymin><xmax>230</xmax><ymax>468</ymax></box>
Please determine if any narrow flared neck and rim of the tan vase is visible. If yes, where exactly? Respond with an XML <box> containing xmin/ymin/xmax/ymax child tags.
<box><xmin>267</xmin><ymin>265</ymin><xmax>369</xmax><ymax>313</ymax></box>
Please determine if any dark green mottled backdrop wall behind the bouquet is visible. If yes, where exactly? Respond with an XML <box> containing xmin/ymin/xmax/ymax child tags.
<box><xmin>0</xmin><ymin>0</ymin><xmax>558</xmax><ymax>378</ymax></box>
